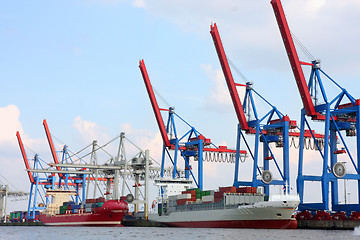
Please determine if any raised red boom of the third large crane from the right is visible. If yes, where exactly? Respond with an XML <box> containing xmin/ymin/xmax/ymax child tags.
<box><xmin>139</xmin><ymin>59</ymin><xmax>171</xmax><ymax>148</ymax></box>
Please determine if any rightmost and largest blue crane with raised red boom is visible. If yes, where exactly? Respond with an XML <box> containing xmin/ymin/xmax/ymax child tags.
<box><xmin>271</xmin><ymin>0</ymin><xmax>360</xmax><ymax>212</ymax></box>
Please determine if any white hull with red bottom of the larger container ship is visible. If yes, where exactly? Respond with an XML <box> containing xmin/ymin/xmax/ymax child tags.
<box><xmin>149</xmin><ymin>195</ymin><xmax>299</xmax><ymax>229</ymax></box>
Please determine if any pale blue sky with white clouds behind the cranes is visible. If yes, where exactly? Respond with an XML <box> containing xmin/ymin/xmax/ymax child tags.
<box><xmin>0</xmin><ymin>0</ymin><xmax>360</xmax><ymax>213</ymax></box>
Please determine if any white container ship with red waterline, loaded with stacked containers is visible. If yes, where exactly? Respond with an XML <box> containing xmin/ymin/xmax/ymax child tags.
<box><xmin>149</xmin><ymin>180</ymin><xmax>300</xmax><ymax>229</ymax></box>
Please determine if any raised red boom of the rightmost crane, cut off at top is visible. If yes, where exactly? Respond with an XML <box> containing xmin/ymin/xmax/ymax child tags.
<box><xmin>271</xmin><ymin>0</ymin><xmax>318</xmax><ymax>116</ymax></box>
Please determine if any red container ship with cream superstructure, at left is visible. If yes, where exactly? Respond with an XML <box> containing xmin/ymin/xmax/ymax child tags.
<box><xmin>39</xmin><ymin>190</ymin><xmax>129</xmax><ymax>227</ymax></box>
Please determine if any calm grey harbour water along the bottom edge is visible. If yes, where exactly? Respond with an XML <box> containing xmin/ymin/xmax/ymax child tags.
<box><xmin>0</xmin><ymin>227</ymin><xmax>360</xmax><ymax>240</ymax></box>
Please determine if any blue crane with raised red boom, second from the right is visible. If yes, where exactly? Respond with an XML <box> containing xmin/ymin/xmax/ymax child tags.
<box><xmin>210</xmin><ymin>23</ymin><xmax>306</xmax><ymax>195</ymax></box>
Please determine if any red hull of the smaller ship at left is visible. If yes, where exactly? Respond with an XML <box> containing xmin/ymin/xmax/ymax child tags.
<box><xmin>39</xmin><ymin>200</ymin><xmax>128</xmax><ymax>227</ymax></box>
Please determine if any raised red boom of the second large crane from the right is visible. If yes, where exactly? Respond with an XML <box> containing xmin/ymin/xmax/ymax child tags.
<box><xmin>210</xmin><ymin>23</ymin><xmax>249</xmax><ymax>130</ymax></box>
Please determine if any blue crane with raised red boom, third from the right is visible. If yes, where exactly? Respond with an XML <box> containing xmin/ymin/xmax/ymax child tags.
<box><xmin>139</xmin><ymin>60</ymin><xmax>246</xmax><ymax>189</ymax></box>
